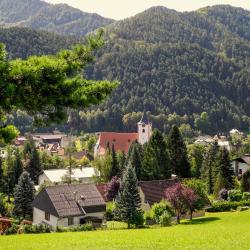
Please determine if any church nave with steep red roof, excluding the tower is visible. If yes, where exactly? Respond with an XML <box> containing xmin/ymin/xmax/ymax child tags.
<box><xmin>97</xmin><ymin>132</ymin><xmax>138</xmax><ymax>155</ymax></box>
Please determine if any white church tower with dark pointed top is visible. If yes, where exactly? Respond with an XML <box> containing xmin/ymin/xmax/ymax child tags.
<box><xmin>137</xmin><ymin>111</ymin><xmax>152</xmax><ymax>145</ymax></box>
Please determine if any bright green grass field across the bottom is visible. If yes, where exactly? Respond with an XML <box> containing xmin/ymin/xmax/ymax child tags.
<box><xmin>0</xmin><ymin>211</ymin><xmax>250</xmax><ymax>250</ymax></box>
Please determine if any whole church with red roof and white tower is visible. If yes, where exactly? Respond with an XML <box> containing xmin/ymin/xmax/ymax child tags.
<box><xmin>95</xmin><ymin>112</ymin><xmax>152</xmax><ymax>157</ymax></box>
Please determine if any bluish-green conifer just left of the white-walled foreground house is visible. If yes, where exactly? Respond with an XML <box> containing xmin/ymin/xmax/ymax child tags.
<box><xmin>13</xmin><ymin>171</ymin><xmax>35</xmax><ymax>218</ymax></box>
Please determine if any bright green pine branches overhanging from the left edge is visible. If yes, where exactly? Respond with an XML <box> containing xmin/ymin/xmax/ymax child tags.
<box><xmin>0</xmin><ymin>31</ymin><xmax>117</xmax><ymax>145</ymax></box>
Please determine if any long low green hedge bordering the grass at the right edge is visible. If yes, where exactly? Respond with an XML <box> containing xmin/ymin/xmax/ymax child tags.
<box><xmin>207</xmin><ymin>201</ymin><xmax>250</xmax><ymax>212</ymax></box>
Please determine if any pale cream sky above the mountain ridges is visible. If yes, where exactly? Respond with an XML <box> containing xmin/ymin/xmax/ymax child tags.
<box><xmin>45</xmin><ymin>0</ymin><xmax>250</xmax><ymax>20</ymax></box>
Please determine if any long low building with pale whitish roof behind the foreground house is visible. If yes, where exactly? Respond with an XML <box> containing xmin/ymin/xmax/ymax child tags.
<box><xmin>38</xmin><ymin>167</ymin><xmax>99</xmax><ymax>186</ymax></box>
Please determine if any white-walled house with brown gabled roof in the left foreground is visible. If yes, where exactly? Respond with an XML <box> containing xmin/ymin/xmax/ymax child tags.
<box><xmin>32</xmin><ymin>184</ymin><xmax>106</xmax><ymax>229</ymax></box>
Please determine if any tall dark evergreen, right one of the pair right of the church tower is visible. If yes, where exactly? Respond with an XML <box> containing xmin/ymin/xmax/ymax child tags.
<box><xmin>168</xmin><ymin>126</ymin><xmax>191</xmax><ymax>178</ymax></box>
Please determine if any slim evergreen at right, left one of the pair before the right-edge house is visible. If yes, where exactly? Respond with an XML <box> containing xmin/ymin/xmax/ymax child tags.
<box><xmin>201</xmin><ymin>142</ymin><xmax>219</xmax><ymax>194</ymax></box>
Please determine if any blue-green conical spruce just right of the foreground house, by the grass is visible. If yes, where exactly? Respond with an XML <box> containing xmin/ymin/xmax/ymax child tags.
<box><xmin>116</xmin><ymin>164</ymin><xmax>141</xmax><ymax>228</ymax></box>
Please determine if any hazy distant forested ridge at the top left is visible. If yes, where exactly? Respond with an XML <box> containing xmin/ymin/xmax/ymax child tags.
<box><xmin>0</xmin><ymin>0</ymin><xmax>113</xmax><ymax>36</ymax></box>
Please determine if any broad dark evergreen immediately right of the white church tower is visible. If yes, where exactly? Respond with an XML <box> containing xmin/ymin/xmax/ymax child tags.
<box><xmin>141</xmin><ymin>129</ymin><xmax>171</xmax><ymax>180</ymax></box>
